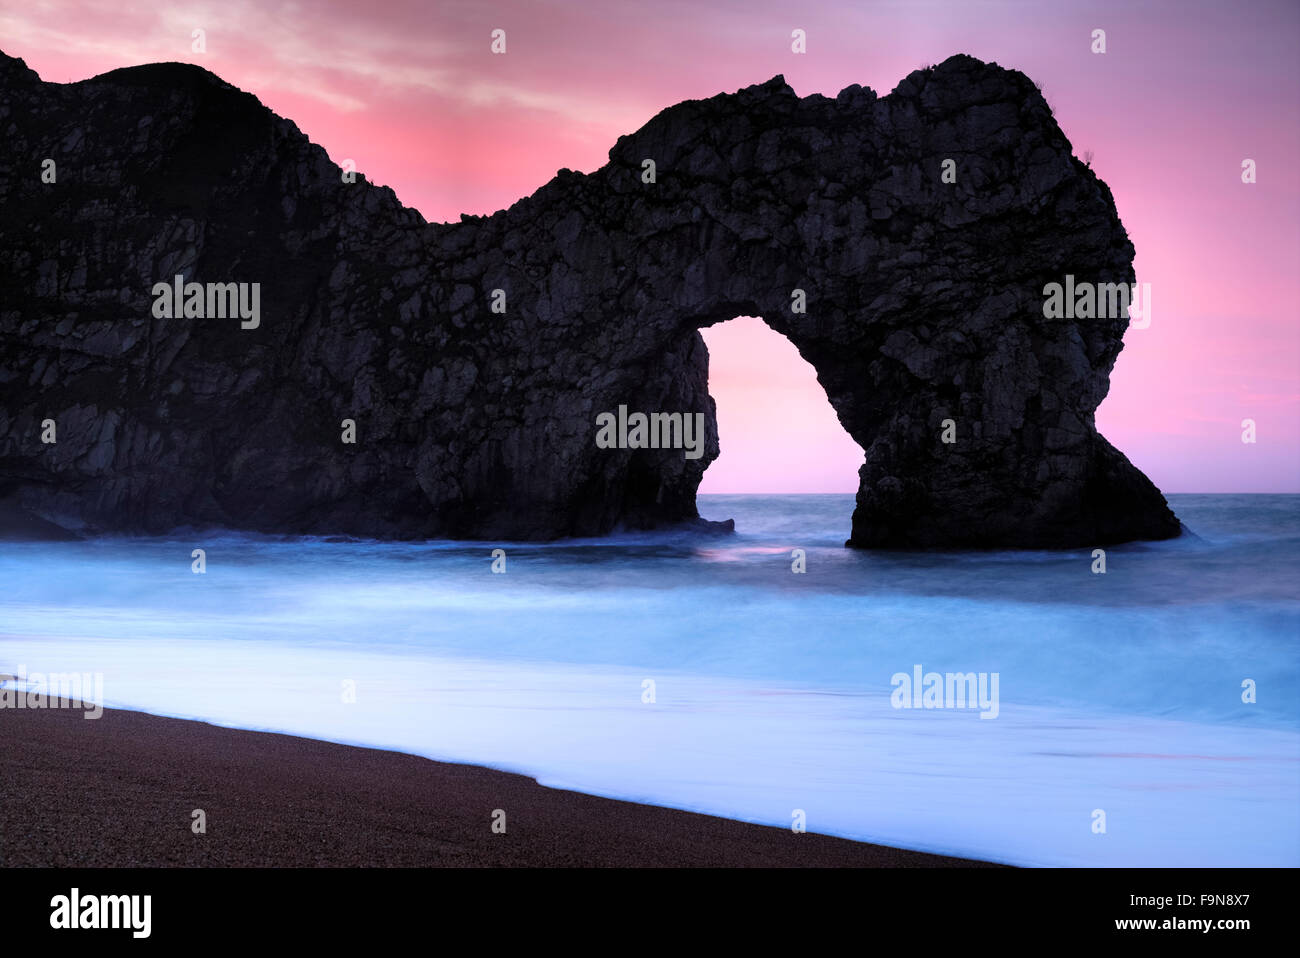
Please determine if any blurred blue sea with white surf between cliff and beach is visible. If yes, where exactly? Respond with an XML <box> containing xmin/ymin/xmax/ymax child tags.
<box><xmin>0</xmin><ymin>495</ymin><xmax>1300</xmax><ymax>866</ymax></box>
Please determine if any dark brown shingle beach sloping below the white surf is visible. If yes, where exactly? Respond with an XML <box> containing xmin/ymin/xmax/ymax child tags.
<box><xmin>0</xmin><ymin>708</ymin><xmax>998</xmax><ymax>867</ymax></box>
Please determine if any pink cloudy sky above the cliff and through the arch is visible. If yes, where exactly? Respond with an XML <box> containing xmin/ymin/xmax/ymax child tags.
<box><xmin>0</xmin><ymin>0</ymin><xmax>1300</xmax><ymax>493</ymax></box>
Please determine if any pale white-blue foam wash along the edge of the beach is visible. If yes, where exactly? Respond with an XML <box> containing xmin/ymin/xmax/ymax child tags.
<box><xmin>0</xmin><ymin>637</ymin><xmax>1300</xmax><ymax>866</ymax></box>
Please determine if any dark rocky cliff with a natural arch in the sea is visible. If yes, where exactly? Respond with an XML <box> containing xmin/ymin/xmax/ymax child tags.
<box><xmin>0</xmin><ymin>55</ymin><xmax>1179</xmax><ymax>547</ymax></box>
